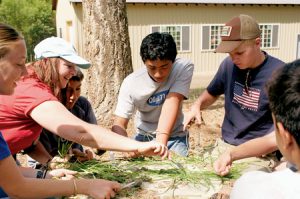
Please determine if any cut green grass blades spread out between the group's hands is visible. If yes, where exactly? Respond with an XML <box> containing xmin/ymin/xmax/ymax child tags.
<box><xmin>61</xmin><ymin>152</ymin><xmax>245</xmax><ymax>196</ymax></box>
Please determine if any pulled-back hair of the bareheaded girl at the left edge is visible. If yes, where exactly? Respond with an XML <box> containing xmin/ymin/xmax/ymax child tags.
<box><xmin>0</xmin><ymin>23</ymin><xmax>24</xmax><ymax>58</ymax></box>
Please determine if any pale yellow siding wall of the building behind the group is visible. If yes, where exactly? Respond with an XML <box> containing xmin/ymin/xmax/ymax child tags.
<box><xmin>56</xmin><ymin>0</ymin><xmax>300</xmax><ymax>87</ymax></box>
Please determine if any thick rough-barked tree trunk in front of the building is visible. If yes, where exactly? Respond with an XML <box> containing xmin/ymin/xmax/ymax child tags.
<box><xmin>82</xmin><ymin>0</ymin><xmax>132</xmax><ymax>127</ymax></box>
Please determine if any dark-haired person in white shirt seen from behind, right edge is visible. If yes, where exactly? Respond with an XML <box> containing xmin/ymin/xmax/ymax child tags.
<box><xmin>230</xmin><ymin>60</ymin><xmax>300</xmax><ymax>199</ymax></box>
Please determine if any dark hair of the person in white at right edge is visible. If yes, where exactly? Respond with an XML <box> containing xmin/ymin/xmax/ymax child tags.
<box><xmin>267</xmin><ymin>60</ymin><xmax>300</xmax><ymax>146</ymax></box>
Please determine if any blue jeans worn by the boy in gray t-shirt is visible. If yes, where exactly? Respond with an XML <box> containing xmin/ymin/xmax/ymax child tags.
<box><xmin>134</xmin><ymin>133</ymin><xmax>189</xmax><ymax>157</ymax></box>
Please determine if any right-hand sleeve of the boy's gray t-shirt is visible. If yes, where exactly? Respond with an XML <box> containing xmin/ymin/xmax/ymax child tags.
<box><xmin>170</xmin><ymin>60</ymin><xmax>194</xmax><ymax>99</ymax></box>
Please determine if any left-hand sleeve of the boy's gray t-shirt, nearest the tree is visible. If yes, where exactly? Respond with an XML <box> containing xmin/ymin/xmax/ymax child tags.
<box><xmin>115</xmin><ymin>78</ymin><xmax>134</xmax><ymax>119</ymax></box>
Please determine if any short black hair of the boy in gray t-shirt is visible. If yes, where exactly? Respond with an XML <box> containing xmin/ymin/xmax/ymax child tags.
<box><xmin>140</xmin><ymin>32</ymin><xmax>177</xmax><ymax>62</ymax></box>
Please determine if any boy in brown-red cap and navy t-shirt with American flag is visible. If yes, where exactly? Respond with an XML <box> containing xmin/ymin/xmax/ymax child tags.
<box><xmin>184</xmin><ymin>15</ymin><xmax>284</xmax><ymax>173</ymax></box>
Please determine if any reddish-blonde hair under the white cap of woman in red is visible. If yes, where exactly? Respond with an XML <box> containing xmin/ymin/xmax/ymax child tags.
<box><xmin>26</xmin><ymin>57</ymin><xmax>61</xmax><ymax>100</ymax></box>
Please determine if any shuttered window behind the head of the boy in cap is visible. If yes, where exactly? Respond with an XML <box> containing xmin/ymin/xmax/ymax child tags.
<box><xmin>202</xmin><ymin>24</ymin><xmax>279</xmax><ymax>50</ymax></box>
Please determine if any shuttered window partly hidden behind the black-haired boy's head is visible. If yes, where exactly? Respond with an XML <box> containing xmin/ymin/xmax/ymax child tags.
<box><xmin>151</xmin><ymin>26</ymin><xmax>190</xmax><ymax>52</ymax></box>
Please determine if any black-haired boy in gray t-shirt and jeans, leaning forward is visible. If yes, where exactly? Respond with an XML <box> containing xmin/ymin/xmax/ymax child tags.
<box><xmin>112</xmin><ymin>32</ymin><xmax>194</xmax><ymax>156</ymax></box>
